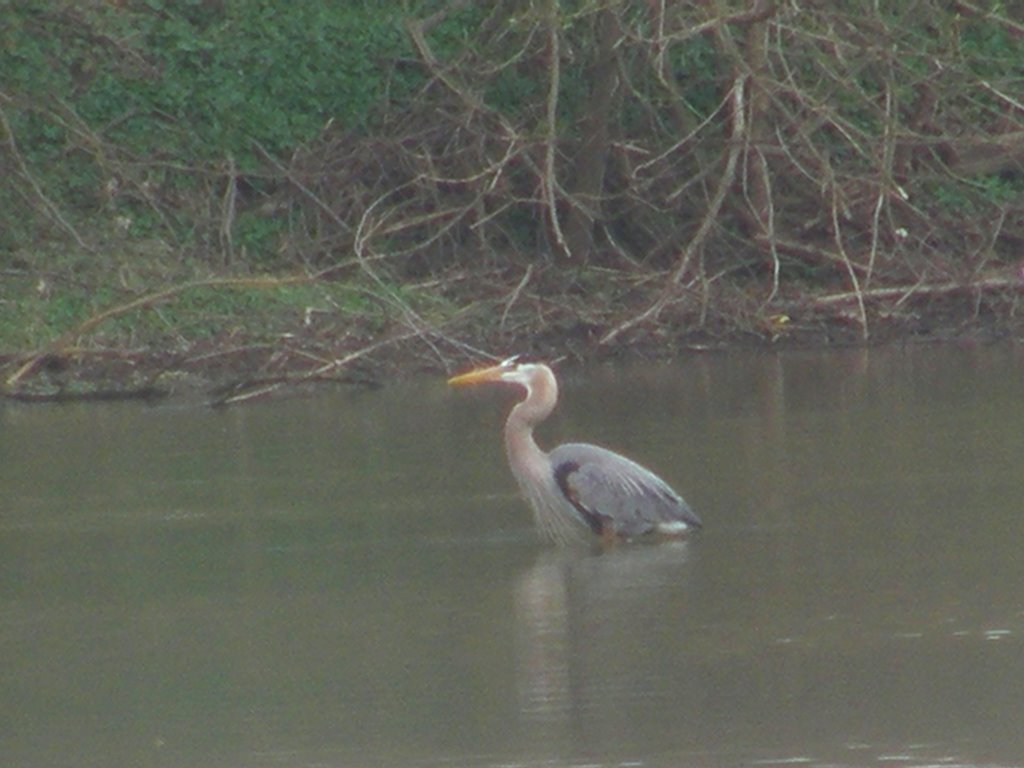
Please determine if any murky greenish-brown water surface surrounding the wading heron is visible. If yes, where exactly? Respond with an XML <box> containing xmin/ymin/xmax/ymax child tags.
<box><xmin>0</xmin><ymin>345</ymin><xmax>1024</xmax><ymax>768</ymax></box>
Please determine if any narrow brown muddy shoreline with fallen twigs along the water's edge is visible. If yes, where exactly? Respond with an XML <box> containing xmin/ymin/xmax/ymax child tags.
<box><xmin>0</xmin><ymin>286</ymin><xmax>1024</xmax><ymax>406</ymax></box>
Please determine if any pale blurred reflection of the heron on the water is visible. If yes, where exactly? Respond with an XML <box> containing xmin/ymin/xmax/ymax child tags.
<box><xmin>515</xmin><ymin>541</ymin><xmax>691</xmax><ymax>740</ymax></box>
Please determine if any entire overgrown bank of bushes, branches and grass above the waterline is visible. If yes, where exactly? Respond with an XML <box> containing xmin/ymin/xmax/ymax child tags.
<box><xmin>0</xmin><ymin>0</ymin><xmax>1024</xmax><ymax>403</ymax></box>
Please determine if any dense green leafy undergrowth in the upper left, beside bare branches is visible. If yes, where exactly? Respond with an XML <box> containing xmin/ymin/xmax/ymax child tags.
<box><xmin>0</xmin><ymin>2</ymin><xmax>415</xmax><ymax>257</ymax></box>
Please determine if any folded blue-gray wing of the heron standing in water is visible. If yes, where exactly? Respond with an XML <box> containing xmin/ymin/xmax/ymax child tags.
<box><xmin>551</xmin><ymin>442</ymin><xmax>701</xmax><ymax>536</ymax></box>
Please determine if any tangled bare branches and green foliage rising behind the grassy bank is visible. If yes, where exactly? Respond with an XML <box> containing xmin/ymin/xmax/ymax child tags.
<box><xmin>0</xmin><ymin>0</ymin><xmax>1024</xmax><ymax>346</ymax></box>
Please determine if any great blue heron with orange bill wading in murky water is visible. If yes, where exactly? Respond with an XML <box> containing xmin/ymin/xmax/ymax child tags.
<box><xmin>449</xmin><ymin>357</ymin><xmax>701</xmax><ymax>543</ymax></box>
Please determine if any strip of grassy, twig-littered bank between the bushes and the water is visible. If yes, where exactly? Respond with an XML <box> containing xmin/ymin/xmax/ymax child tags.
<box><xmin>0</xmin><ymin>267</ymin><xmax>1024</xmax><ymax>404</ymax></box>
